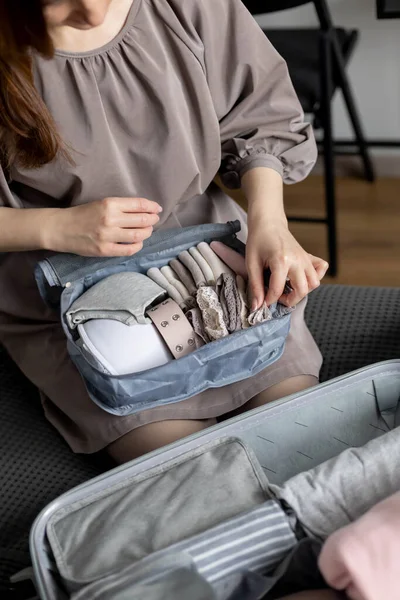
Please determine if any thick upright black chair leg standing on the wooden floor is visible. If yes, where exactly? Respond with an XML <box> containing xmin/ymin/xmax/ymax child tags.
<box><xmin>320</xmin><ymin>32</ymin><xmax>338</xmax><ymax>277</ymax></box>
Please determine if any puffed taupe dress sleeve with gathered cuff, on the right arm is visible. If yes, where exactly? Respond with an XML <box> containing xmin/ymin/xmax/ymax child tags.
<box><xmin>198</xmin><ymin>0</ymin><xmax>317</xmax><ymax>188</ymax></box>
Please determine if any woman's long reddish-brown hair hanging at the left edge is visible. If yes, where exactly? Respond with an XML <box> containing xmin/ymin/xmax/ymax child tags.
<box><xmin>0</xmin><ymin>0</ymin><xmax>66</xmax><ymax>168</ymax></box>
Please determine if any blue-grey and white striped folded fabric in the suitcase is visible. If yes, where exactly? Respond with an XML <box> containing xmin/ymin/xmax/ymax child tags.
<box><xmin>168</xmin><ymin>500</ymin><xmax>297</xmax><ymax>583</ymax></box>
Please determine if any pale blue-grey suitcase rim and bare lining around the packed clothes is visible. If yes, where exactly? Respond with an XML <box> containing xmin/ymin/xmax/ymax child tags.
<box><xmin>31</xmin><ymin>360</ymin><xmax>400</xmax><ymax>600</ymax></box>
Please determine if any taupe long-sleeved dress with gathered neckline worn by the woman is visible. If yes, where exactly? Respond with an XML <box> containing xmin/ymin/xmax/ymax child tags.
<box><xmin>0</xmin><ymin>0</ymin><xmax>321</xmax><ymax>452</ymax></box>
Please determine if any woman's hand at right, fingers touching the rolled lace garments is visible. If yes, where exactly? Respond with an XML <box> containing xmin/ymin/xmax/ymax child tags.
<box><xmin>246</xmin><ymin>220</ymin><xmax>329</xmax><ymax>310</ymax></box>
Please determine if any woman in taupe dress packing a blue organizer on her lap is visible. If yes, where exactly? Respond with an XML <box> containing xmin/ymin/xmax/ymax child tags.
<box><xmin>0</xmin><ymin>0</ymin><xmax>327</xmax><ymax>462</ymax></box>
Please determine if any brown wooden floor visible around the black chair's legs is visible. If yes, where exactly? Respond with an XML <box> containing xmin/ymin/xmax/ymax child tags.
<box><xmin>225</xmin><ymin>176</ymin><xmax>400</xmax><ymax>286</ymax></box>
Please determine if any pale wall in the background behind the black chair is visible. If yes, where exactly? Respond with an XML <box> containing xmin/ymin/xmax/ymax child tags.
<box><xmin>259</xmin><ymin>0</ymin><xmax>400</xmax><ymax>139</ymax></box>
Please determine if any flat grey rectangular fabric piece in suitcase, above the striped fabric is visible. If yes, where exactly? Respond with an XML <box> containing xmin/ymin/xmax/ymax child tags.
<box><xmin>47</xmin><ymin>439</ymin><xmax>270</xmax><ymax>591</ymax></box>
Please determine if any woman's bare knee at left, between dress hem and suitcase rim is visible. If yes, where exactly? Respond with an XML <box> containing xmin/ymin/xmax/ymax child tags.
<box><xmin>107</xmin><ymin>419</ymin><xmax>216</xmax><ymax>463</ymax></box>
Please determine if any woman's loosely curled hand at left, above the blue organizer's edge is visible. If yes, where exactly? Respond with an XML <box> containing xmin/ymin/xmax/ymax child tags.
<box><xmin>41</xmin><ymin>198</ymin><xmax>162</xmax><ymax>256</ymax></box>
